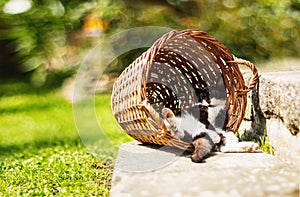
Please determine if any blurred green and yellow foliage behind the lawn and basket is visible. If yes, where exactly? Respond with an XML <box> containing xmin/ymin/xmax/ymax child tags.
<box><xmin>0</xmin><ymin>0</ymin><xmax>300</xmax><ymax>81</ymax></box>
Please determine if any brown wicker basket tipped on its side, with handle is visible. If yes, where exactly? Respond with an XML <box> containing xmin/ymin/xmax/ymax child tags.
<box><xmin>111</xmin><ymin>30</ymin><xmax>258</xmax><ymax>150</ymax></box>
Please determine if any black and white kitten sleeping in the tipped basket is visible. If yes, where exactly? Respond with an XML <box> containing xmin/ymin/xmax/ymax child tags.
<box><xmin>162</xmin><ymin>98</ymin><xmax>258</xmax><ymax>162</ymax></box>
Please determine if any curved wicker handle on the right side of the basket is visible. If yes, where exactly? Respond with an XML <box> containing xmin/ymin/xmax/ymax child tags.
<box><xmin>227</xmin><ymin>58</ymin><xmax>258</xmax><ymax>94</ymax></box>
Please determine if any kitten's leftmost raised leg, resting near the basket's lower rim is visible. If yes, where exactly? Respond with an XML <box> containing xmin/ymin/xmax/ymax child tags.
<box><xmin>162</xmin><ymin>108</ymin><xmax>184</xmax><ymax>139</ymax></box>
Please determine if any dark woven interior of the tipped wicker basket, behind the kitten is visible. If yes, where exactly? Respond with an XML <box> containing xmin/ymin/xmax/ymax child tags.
<box><xmin>146</xmin><ymin>40</ymin><xmax>227</xmax><ymax>130</ymax></box>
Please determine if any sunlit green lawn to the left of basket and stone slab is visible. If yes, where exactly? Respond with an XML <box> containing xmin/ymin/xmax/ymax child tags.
<box><xmin>0</xmin><ymin>79</ymin><xmax>130</xmax><ymax>196</ymax></box>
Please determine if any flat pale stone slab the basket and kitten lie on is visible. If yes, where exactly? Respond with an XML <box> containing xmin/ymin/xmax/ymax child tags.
<box><xmin>111</xmin><ymin>142</ymin><xmax>300</xmax><ymax>197</ymax></box>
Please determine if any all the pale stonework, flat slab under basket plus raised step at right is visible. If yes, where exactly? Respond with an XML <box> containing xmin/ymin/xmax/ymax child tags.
<box><xmin>111</xmin><ymin>70</ymin><xmax>300</xmax><ymax>197</ymax></box>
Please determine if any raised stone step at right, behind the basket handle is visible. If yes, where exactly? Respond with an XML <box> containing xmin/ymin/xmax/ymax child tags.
<box><xmin>240</xmin><ymin>70</ymin><xmax>300</xmax><ymax>169</ymax></box>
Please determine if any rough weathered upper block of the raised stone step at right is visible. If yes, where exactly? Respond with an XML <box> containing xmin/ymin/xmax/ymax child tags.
<box><xmin>259</xmin><ymin>71</ymin><xmax>300</xmax><ymax>135</ymax></box>
